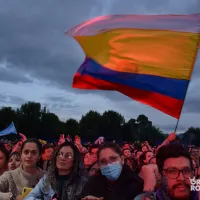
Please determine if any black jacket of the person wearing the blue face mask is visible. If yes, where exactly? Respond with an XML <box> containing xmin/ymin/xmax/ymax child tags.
<box><xmin>81</xmin><ymin>165</ymin><xmax>144</xmax><ymax>200</ymax></box>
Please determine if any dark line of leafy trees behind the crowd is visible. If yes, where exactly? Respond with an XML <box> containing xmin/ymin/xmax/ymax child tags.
<box><xmin>0</xmin><ymin>102</ymin><xmax>200</xmax><ymax>145</ymax></box>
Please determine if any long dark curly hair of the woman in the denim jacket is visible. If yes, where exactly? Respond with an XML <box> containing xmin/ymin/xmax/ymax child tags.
<box><xmin>45</xmin><ymin>142</ymin><xmax>85</xmax><ymax>191</ymax></box>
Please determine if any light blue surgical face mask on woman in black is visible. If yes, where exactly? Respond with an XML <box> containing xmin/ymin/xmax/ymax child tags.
<box><xmin>100</xmin><ymin>162</ymin><xmax>122</xmax><ymax>181</ymax></box>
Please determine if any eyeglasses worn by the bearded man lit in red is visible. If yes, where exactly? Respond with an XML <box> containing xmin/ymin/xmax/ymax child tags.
<box><xmin>163</xmin><ymin>168</ymin><xmax>193</xmax><ymax>179</ymax></box>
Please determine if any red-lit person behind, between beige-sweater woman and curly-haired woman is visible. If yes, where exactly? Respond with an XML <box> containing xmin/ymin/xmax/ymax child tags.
<box><xmin>39</xmin><ymin>143</ymin><xmax>54</xmax><ymax>171</ymax></box>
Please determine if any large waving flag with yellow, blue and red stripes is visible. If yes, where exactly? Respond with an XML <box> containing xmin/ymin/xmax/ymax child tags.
<box><xmin>66</xmin><ymin>13</ymin><xmax>200</xmax><ymax>119</ymax></box>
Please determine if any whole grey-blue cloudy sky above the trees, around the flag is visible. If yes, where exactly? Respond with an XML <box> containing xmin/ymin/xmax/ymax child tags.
<box><xmin>0</xmin><ymin>0</ymin><xmax>200</xmax><ymax>132</ymax></box>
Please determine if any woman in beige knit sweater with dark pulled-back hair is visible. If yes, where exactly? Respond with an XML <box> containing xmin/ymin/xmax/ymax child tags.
<box><xmin>0</xmin><ymin>139</ymin><xmax>45</xmax><ymax>200</ymax></box>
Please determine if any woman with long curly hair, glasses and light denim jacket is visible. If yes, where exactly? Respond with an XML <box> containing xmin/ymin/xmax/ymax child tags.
<box><xmin>25</xmin><ymin>142</ymin><xmax>87</xmax><ymax>200</ymax></box>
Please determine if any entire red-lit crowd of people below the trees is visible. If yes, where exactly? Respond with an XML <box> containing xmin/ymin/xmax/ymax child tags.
<box><xmin>0</xmin><ymin>133</ymin><xmax>200</xmax><ymax>200</ymax></box>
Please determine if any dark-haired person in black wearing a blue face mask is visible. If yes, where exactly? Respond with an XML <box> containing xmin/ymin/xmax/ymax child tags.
<box><xmin>81</xmin><ymin>143</ymin><xmax>143</xmax><ymax>200</ymax></box>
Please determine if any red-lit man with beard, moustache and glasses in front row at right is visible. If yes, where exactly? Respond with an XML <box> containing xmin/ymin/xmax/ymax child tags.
<box><xmin>136</xmin><ymin>144</ymin><xmax>198</xmax><ymax>200</ymax></box>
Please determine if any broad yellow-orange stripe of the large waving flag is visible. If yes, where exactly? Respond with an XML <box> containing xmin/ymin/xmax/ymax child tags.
<box><xmin>75</xmin><ymin>29</ymin><xmax>199</xmax><ymax>80</ymax></box>
